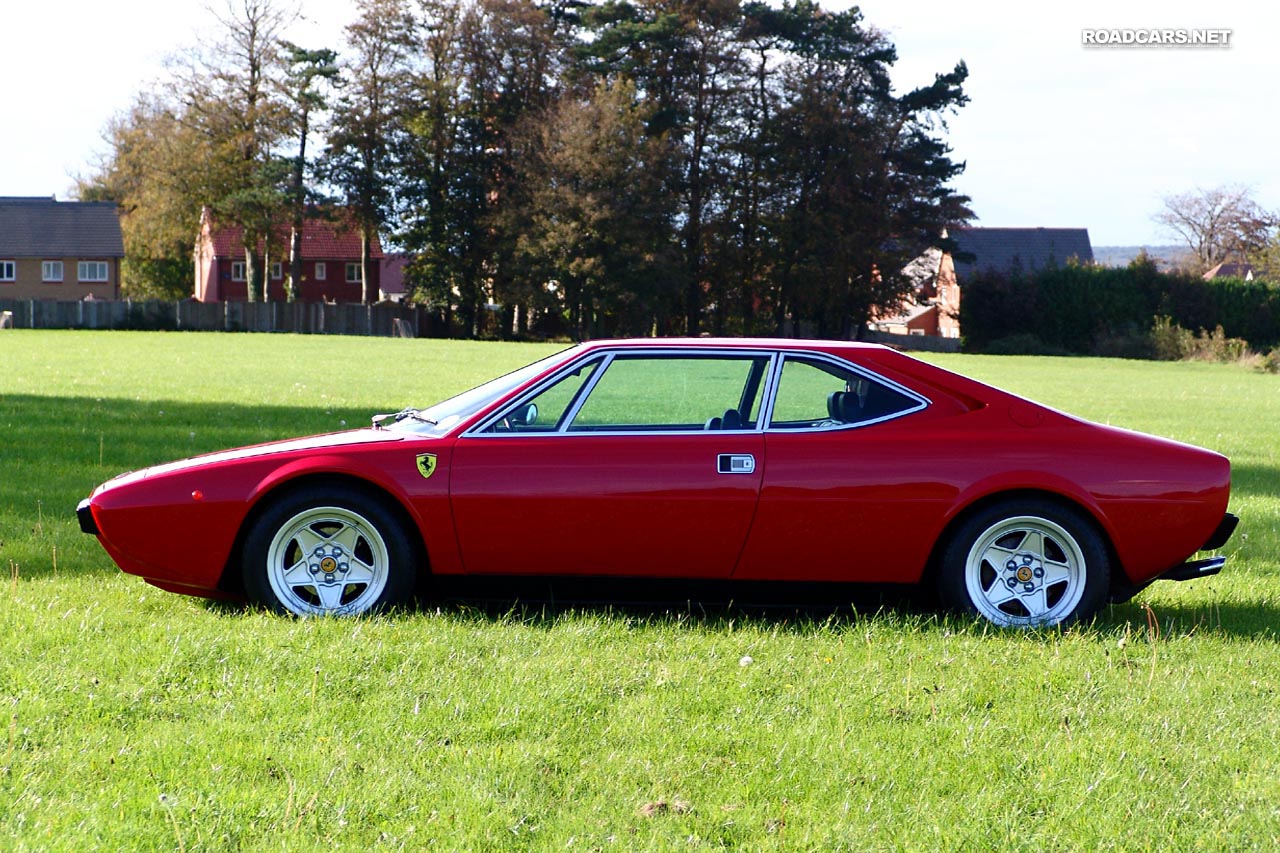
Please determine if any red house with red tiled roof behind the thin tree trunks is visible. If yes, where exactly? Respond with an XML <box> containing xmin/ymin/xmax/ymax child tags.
<box><xmin>196</xmin><ymin>207</ymin><xmax>383</xmax><ymax>302</ymax></box>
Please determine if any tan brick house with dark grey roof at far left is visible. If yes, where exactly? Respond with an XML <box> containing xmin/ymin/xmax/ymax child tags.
<box><xmin>0</xmin><ymin>197</ymin><xmax>124</xmax><ymax>301</ymax></box>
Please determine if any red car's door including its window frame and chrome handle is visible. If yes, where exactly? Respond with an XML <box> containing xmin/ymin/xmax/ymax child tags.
<box><xmin>449</xmin><ymin>350</ymin><xmax>772</xmax><ymax>578</ymax></box>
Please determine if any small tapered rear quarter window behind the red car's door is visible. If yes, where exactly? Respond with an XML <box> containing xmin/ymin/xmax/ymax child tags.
<box><xmin>769</xmin><ymin>359</ymin><xmax>924</xmax><ymax>429</ymax></box>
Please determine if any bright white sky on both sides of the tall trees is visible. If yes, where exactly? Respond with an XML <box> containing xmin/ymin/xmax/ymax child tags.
<box><xmin>0</xmin><ymin>0</ymin><xmax>1280</xmax><ymax>246</ymax></box>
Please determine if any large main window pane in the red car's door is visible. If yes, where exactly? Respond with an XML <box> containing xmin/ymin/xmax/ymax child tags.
<box><xmin>568</xmin><ymin>355</ymin><xmax>769</xmax><ymax>433</ymax></box>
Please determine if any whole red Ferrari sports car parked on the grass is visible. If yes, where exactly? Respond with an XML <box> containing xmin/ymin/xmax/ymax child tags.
<box><xmin>78</xmin><ymin>338</ymin><xmax>1236</xmax><ymax>626</ymax></box>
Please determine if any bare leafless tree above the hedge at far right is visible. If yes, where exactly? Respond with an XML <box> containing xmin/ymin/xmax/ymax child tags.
<box><xmin>1152</xmin><ymin>184</ymin><xmax>1280</xmax><ymax>273</ymax></box>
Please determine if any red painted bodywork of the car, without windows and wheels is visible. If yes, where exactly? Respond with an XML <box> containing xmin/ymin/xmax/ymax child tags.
<box><xmin>77</xmin><ymin>339</ymin><xmax>1230</xmax><ymax>596</ymax></box>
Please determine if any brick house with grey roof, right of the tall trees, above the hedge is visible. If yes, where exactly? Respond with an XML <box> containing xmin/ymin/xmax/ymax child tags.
<box><xmin>870</xmin><ymin>228</ymin><xmax>1093</xmax><ymax>338</ymax></box>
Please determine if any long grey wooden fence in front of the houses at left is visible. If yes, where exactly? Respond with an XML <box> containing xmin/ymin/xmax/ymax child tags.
<box><xmin>0</xmin><ymin>300</ymin><xmax>443</xmax><ymax>337</ymax></box>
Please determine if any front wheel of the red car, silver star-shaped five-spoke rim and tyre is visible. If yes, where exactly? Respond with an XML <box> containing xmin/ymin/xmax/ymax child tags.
<box><xmin>243</xmin><ymin>487</ymin><xmax>415</xmax><ymax>616</ymax></box>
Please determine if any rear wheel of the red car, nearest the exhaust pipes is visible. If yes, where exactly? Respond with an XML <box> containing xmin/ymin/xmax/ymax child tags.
<box><xmin>938</xmin><ymin>498</ymin><xmax>1110</xmax><ymax>628</ymax></box>
